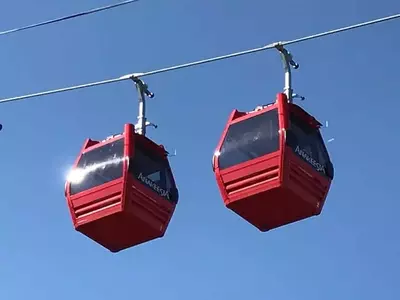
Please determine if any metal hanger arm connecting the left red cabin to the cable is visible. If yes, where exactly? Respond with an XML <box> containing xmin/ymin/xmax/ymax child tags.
<box><xmin>128</xmin><ymin>74</ymin><xmax>158</xmax><ymax>135</ymax></box>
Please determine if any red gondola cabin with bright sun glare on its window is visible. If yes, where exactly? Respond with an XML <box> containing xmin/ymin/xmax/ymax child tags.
<box><xmin>65</xmin><ymin>124</ymin><xmax>178</xmax><ymax>252</ymax></box>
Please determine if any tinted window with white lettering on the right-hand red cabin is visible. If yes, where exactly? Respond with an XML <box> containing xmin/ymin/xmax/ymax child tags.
<box><xmin>286</xmin><ymin>113</ymin><xmax>333</xmax><ymax>178</ymax></box>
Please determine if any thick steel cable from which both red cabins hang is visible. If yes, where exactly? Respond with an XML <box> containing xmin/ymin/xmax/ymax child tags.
<box><xmin>0</xmin><ymin>14</ymin><xmax>400</xmax><ymax>103</ymax></box>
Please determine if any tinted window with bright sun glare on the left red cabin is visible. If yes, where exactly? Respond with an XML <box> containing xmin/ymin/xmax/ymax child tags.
<box><xmin>70</xmin><ymin>139</ymin><xmax>124</xmax><ymax>195</ymax></box>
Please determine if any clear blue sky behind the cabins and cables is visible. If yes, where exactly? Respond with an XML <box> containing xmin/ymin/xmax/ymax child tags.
<box><xmin>0</xmin><ymin>0</ymin><xmax>400</xmax><ymax>300</ymax></box>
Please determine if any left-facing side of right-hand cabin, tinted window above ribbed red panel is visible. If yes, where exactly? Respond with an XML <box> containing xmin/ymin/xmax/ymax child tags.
<box><xmin>218</xmin><ymin>105</ymin><xmax>281</xmax><ymax>204</ymax></box>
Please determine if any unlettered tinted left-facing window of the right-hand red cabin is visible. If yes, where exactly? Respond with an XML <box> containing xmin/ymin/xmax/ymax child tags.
<box><xmin>219</xmin><ymin>109</ymin><xmax>279</xmax><ymax>169</ymax></box>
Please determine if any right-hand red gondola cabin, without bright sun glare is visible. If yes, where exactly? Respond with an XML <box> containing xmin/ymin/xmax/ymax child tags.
<box><xmin>213</xmin><ymin>93</ymin><xmax>334</xmax><ymax>231</ymax></box>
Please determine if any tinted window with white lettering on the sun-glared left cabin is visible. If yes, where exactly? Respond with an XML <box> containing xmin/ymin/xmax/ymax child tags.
<box><xmin>129</xmin><ymin>144</ymin><xmax>178</xmax><ymax>203</ymax></box>
